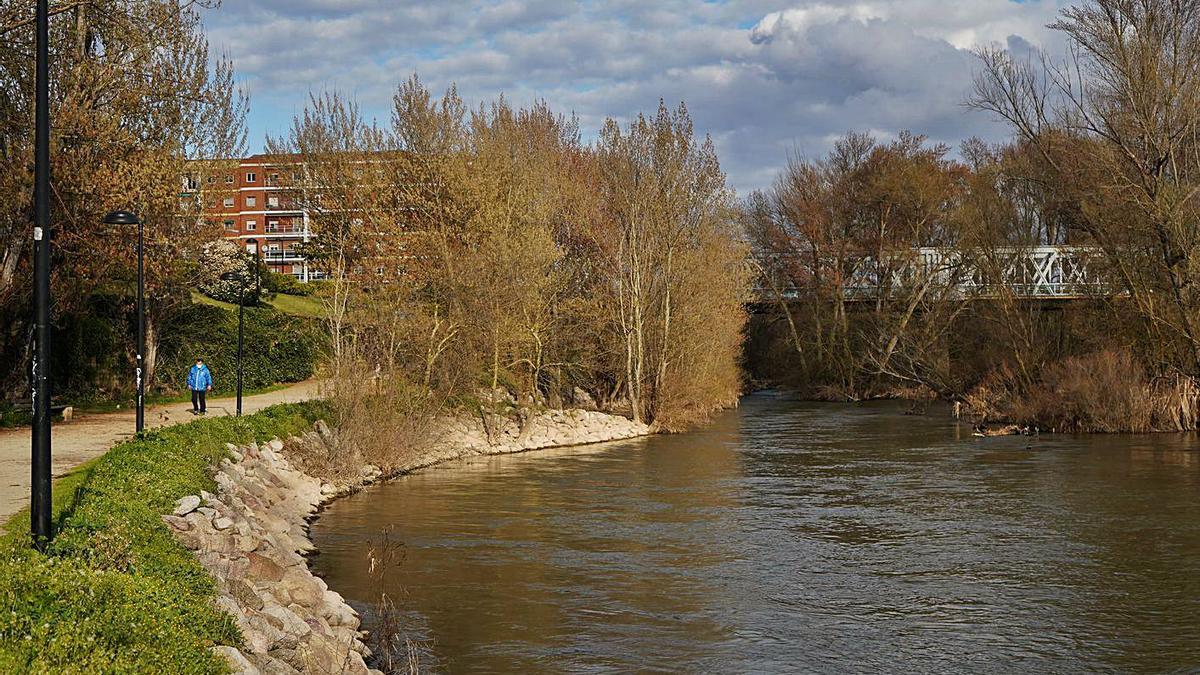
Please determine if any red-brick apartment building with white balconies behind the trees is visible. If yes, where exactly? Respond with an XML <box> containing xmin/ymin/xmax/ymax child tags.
<box><xmin>184</xmin><ymin>155</ymin><xmax>324</xmax><ymax>281</ymax></box>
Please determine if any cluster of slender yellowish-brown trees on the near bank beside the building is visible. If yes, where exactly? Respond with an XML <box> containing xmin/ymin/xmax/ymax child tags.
<box><xmin>269</xmin><ymin>76</ymin><xmax>749</xmax><ymax>429</ymax></box>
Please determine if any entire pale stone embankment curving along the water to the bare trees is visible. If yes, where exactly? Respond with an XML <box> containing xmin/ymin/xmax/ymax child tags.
<box><xmin>163</xmin><ymin>410</ymin><xmax>650</xmax><ymax>674</ymax></box>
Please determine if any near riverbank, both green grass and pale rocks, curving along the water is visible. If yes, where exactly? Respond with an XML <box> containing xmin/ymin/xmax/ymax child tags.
<box><xmin>0</xmin><ymin>401</ymin><xmax>649</xmax><ymax>673</ymax></box>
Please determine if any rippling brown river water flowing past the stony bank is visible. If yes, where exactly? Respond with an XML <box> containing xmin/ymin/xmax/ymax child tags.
<box><xmin>312</xmin><ymin>394</ymin><xmax>1200</xmax><ymax>673</ymax></box>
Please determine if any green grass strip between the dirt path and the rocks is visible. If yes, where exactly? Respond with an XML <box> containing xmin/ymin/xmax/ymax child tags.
<box><xmin>0</xmin><ymin>401</ymin><xmax>329</xmax><ymax>673</ymax></box>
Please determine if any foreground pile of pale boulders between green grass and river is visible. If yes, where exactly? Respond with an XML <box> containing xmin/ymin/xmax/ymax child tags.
<box><xmin>163</xmin><ymin>440</ymin><xmax>371</xmax><ymax>674</ymax></box>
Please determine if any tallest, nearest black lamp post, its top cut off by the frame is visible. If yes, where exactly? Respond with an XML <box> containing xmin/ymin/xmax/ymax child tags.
<box><xmin>29</xmin><ymin>0</ymin><xmax>53</xmax><ymax>549</ymax></box>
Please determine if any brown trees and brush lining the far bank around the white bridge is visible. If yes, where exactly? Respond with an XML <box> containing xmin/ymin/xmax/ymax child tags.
<box><xmin>744</xmin><ymin>0</ymin><xmax>1200</xmax><ymax>431</ymax></box>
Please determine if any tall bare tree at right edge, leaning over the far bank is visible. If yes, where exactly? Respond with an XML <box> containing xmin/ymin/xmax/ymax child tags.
<box><xmin>972</xmin><ymin>0</ymin><xmax>1200</xmax><ymax>375</ymax></box>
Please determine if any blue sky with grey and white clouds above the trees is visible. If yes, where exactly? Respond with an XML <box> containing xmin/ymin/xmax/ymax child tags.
<box><xmin>204</xmin><ymin>0</ymin><xmax>1061</xmax><ymax>195</ymax></box>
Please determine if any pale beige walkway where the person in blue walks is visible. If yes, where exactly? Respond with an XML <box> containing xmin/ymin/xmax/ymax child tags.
<box><xmin>0</xmin><ymin>380</ymin><xmax>319</xmax><ymax>522</ymax></box>
